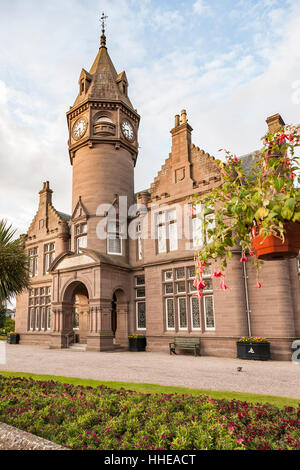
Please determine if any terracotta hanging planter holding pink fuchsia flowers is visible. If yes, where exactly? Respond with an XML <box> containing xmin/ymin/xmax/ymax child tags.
<box><xmin>252</xmin><ymin>222</ymin><xmax>300</xmax><ymax>261</ymax></box>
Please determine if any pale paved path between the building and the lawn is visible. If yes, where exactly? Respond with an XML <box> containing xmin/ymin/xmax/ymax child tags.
<box><xmin>0</xmin><ymin>345</ymin><xmax>300</xmax><ymax>398</ymax></box>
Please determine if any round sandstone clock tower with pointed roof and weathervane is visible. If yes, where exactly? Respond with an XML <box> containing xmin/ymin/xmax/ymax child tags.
<box><xmin>67</xmin><ymin>22</ymin><xmax>140</xmax><ymax>261</ymax></box>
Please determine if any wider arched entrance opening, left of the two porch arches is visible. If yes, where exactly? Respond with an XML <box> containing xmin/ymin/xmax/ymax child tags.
<box><xmin>63</xmin><ymin>281</ymin><xmax>89</xmax><ymax>344</ymax></box>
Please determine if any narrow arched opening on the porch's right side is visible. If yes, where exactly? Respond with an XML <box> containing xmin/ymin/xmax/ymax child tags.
<box><xmin>111</xmin><ymin>289</ymin><xmax>128</xmax><ymax>347</ymax></box>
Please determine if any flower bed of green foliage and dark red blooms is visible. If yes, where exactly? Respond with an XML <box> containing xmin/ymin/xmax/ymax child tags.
<box><xmin>0</xmin><ymin>377</ymin><xmax>300</xmax><ymax>450</ymax></box>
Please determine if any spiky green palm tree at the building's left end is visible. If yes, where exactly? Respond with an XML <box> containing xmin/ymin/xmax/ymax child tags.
<box><xmin>0</xmin><ymin>220</ymin><xmax>29</xmax><ymax>305</ymax></box>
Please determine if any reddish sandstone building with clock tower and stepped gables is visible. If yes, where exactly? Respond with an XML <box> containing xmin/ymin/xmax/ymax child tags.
<box><xmin>16</xmin><ymin>29</ymin><xmax>300</xmax><ymax>360</ymax></box>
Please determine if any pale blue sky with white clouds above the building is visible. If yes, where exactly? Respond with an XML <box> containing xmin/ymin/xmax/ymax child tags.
<box><xmin>0</xmin><ymin>0</ymin><xmax>300</xmax><ymax>233</ymax></box>
